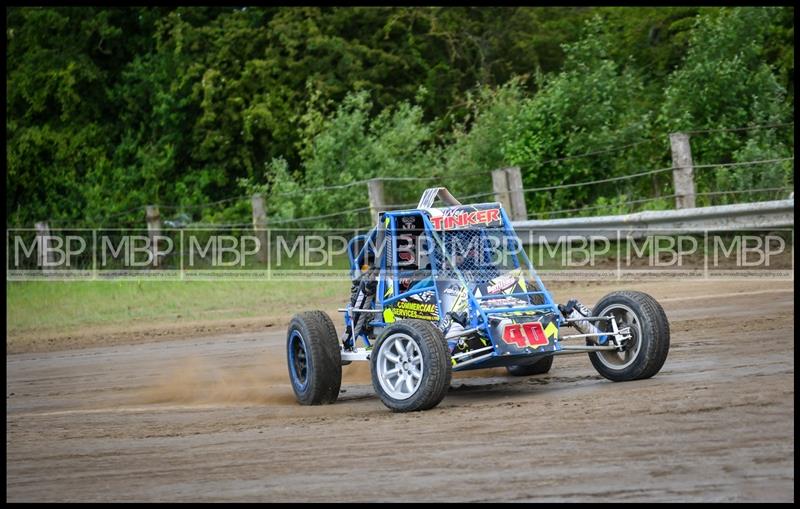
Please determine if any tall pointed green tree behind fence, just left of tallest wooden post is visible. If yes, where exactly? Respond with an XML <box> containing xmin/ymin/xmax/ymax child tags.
<box><xmin>502</xmin><ymin>17</ymin><xmax>663</xmax><ymax>216</ymax></box>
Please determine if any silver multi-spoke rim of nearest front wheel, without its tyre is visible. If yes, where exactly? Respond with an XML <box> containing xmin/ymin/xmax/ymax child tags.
<box><xmin>377</xmin><ymin>333</ymin><xmax>425</xmax><ymax>400</ymax></box>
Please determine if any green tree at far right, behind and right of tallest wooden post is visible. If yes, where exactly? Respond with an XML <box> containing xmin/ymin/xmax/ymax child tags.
<box><xmin>659</xmin><ymin>8</ymin><xmax>793</xmax><ymax>202</ymax></box>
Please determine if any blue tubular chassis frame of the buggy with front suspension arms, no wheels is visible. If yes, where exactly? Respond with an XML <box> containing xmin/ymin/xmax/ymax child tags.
<box><xmin>338</xmin><ymin>188</ymin><xmax>631</xmax><ymax>371</ymax></box>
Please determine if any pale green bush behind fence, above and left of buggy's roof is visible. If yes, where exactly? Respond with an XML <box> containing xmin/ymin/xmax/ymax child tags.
<box><xmin>250</xmin><ymin>92</ymin><xmax>436</xmax><ymax>227</ymax></box>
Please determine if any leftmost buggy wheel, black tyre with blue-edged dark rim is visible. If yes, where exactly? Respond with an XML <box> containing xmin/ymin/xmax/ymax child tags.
<box><xmin>286</xmin><ymin>311</ymin><xmax>342</xmax><ymax>405</ymax></box>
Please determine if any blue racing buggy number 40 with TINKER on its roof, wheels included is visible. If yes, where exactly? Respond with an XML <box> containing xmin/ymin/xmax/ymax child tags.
<box><xmin>286</xmin><ymin>188</ymin><xmax>669</xmax><ymax>412</ymax></box>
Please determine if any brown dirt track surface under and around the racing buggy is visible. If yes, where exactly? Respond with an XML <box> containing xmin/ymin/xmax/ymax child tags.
<box><xmin>6</xmin><ymin>281</ymin><xmax>794</xmax><ymax>502</ymax></box>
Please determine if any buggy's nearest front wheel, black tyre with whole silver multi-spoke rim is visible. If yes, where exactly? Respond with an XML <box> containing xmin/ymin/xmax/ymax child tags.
<box><xmin>370</xmin><ymin>320</ymin><xmax>452</xmax><ymax>412</ymax></box>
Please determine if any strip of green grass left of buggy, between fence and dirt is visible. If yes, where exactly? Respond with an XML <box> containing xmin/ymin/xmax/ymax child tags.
<box><xmin>6</xmin><ymin>281</ymin><xmax>350</xmax><ymax>336</ymax></box>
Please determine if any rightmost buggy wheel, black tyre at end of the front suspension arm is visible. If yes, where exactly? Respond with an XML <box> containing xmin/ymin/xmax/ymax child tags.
<box><xmin>589</xmin><ymin>291</ymin><xmax>669</xmax><ymax>382</ymax></box>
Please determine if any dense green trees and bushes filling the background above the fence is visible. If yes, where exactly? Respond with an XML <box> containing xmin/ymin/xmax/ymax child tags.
<box><xmin>6</xmin><ymin>7</ymin><xmax>794</xmax><ymax>226</ymax></box>
